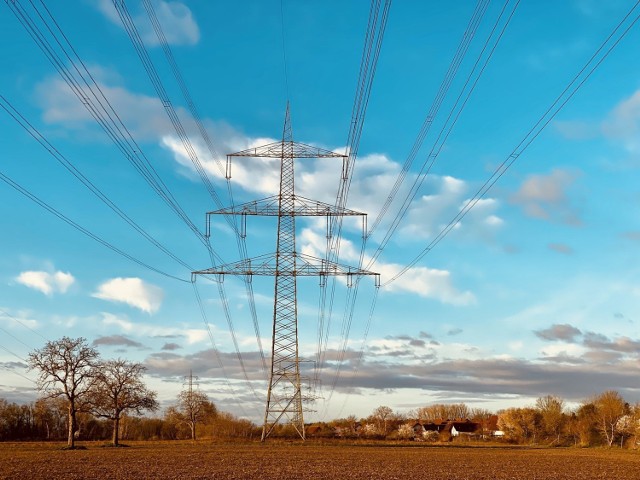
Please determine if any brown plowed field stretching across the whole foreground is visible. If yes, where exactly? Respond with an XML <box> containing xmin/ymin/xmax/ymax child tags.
<box><xmin>0</xmin><ymin>441</ymin><xmax>640</xmax><ymax>480</ymax></box>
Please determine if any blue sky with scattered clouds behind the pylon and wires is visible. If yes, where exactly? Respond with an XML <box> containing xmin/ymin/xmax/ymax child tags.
<box><xmin>0</xmin><ymin>0</ymin><xmax>640</xmax><ymax>420</ymax></box>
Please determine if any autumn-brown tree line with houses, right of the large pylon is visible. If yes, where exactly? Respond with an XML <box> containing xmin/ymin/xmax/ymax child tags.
<box><xmin>306</xmin><ymin>390</ymin><xmax>640</xmax><ymax>448</ymax></box>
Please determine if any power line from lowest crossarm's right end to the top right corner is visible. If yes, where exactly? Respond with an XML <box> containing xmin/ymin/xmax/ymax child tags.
<box><xmin>383</xmin><ymin>1</ymin><xmax>640</xmax><ymax>286</ymax></box>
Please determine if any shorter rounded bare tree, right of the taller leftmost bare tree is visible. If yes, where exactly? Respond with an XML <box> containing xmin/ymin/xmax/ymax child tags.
<box><xmin>88</xmin><ymin>359</ymin><xmax>158</xmax><ymax>447</ymax></box>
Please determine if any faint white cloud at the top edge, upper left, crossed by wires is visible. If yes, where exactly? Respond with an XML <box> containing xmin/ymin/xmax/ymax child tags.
<box><xmin>97</xmin><ymin>0</ymin><xmax>200</xmax><ymax>46</ymax></box>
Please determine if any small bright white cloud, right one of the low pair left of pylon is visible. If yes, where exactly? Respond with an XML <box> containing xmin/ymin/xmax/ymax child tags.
<box><xmin>93</xmin><ymin>277</ymin><xmax>164</xmax><ymax>313</ymax></box>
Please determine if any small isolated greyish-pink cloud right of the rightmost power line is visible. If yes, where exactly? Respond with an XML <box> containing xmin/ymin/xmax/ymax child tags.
<box><xmin>511</xmin><ymin>168</ymin><xmax>582</xmax><ymax>226</ymax></box>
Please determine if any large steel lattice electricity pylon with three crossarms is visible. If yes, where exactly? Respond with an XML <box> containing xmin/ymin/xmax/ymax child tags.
<box><xmin>193</xmin><ymin>105</ymin><xmax>379</xmax><ymax>441</ymax></box>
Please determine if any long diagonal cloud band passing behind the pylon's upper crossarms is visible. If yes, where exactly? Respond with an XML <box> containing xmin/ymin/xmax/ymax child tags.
<box><xmin>37</xmin><ymin>66</ymin><xmax>503</xmax><ymax>251</ymax></box>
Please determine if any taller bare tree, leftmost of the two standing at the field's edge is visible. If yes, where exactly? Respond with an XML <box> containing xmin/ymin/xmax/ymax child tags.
<box><xmin>28</xmin><ymin>337</ymin><xmax>99</xmax><ymax>448</ymax></box>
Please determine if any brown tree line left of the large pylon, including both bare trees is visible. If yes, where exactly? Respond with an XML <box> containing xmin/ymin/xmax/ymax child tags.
<box><xmin>0</xmin><ymin>337</ymin><xmax>255</xmax><ymax>442</ymax></box>
